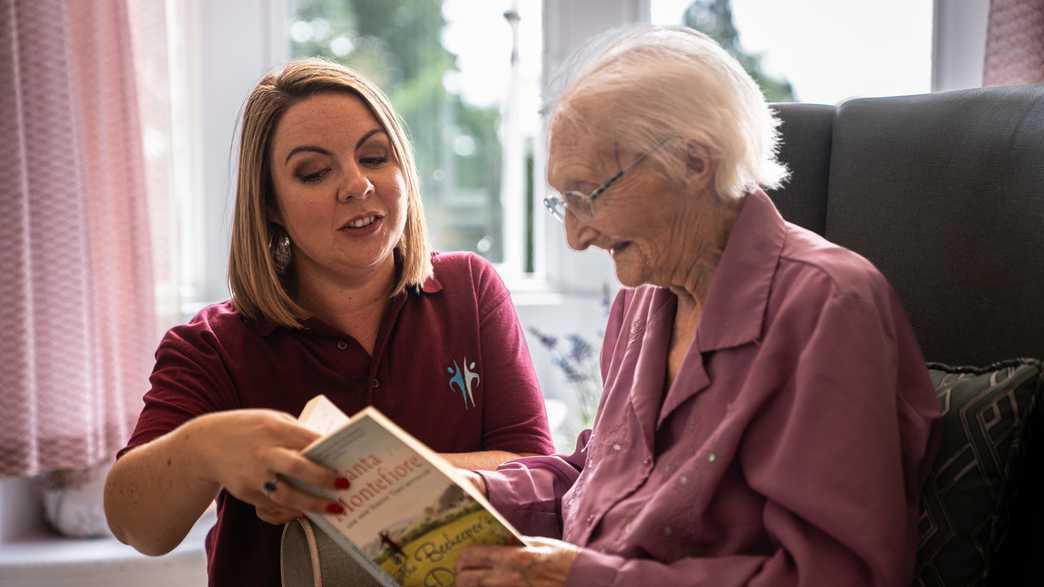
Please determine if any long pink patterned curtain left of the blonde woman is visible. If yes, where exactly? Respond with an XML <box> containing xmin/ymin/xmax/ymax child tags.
<box><xmin>0</xmin><ymin>0</ymin><xmax>156</xmax><ymax>476</ymax></box>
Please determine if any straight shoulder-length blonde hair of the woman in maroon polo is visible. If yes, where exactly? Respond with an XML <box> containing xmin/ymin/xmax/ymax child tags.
<box><xmin>229</xmin><ymin>58</ymin><xmax>432</xmax><ymax>328</ymax></box>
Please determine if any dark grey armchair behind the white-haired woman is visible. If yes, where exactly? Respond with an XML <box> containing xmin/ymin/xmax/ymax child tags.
<box><xmin>770</xmin><ymin>86</ymin><xmax>1044</xmax><ymax>586</ymax></box>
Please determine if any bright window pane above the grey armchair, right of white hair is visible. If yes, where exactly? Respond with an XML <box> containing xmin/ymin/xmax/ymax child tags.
<box><xmin>649</xmin><ymin>0</ymin><xmax>932</xmax><ymax>104</ymax></box>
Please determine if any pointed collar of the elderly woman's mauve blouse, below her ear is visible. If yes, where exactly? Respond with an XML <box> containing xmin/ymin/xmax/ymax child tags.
<box><xmin>696</xmin><ymin>189</ymin><xmax>786</xmax><ymax>351</ymax></box>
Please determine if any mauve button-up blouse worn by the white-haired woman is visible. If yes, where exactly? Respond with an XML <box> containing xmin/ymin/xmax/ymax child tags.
<box><xmin>481</xmin><ymin>191</ymin><xmax>939</xmax><ymax>587</ymax></box>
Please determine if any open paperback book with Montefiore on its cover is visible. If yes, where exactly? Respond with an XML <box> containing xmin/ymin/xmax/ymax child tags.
<box><xmin>287</xmin><ymin>395</ymin><xmax>524</xmax><ymax>587</ymax></box>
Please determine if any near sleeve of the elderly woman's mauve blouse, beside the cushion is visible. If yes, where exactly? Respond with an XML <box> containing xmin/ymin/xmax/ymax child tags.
<box><xmin>567</xmin><ymin>279</ymin><xmax>939</xmax><ymax>587</ymax></box>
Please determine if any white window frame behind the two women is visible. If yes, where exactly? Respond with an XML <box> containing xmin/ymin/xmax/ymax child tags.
<box><xmin>175</xmin><ymin>0</ymin><xmax>989</xmax><ymax>311</ymax></box>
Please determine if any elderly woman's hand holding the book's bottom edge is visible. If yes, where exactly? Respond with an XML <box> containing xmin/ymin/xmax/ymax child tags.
<box><xmin>456</xmin><ymin>538</ymin><xmax>579</xmax><ymax>587</ymax></box>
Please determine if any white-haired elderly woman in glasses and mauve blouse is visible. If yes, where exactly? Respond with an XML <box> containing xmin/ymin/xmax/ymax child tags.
<box><xmin>457</xmin><ymin>27</ymin><xmax>939</xmax><ymax>587</ymax></box>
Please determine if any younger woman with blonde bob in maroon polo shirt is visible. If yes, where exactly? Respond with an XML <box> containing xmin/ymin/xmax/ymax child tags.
<box><xmin>105</xmin><ymin>61</ymin><xmax>551</xmax><ymax>586</ymax></box>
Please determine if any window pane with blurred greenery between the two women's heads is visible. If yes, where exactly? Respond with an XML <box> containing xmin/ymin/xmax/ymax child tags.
<box><xmin>288</xmin><ymin>0</ymin><xmax>542</xmax><ymax>275</ymax></box>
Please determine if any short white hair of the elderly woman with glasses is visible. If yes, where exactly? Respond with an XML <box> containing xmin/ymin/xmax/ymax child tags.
<box><xmin>545</xmin><ymin>25</ymin><xmax>787</xmax><ymax>198</ymax></box>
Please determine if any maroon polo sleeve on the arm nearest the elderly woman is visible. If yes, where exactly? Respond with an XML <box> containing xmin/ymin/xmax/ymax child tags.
<box><xmin>473</xmin><ymin>256</ymin><xmax>554</xmax><ymax>454</ymax></box>
